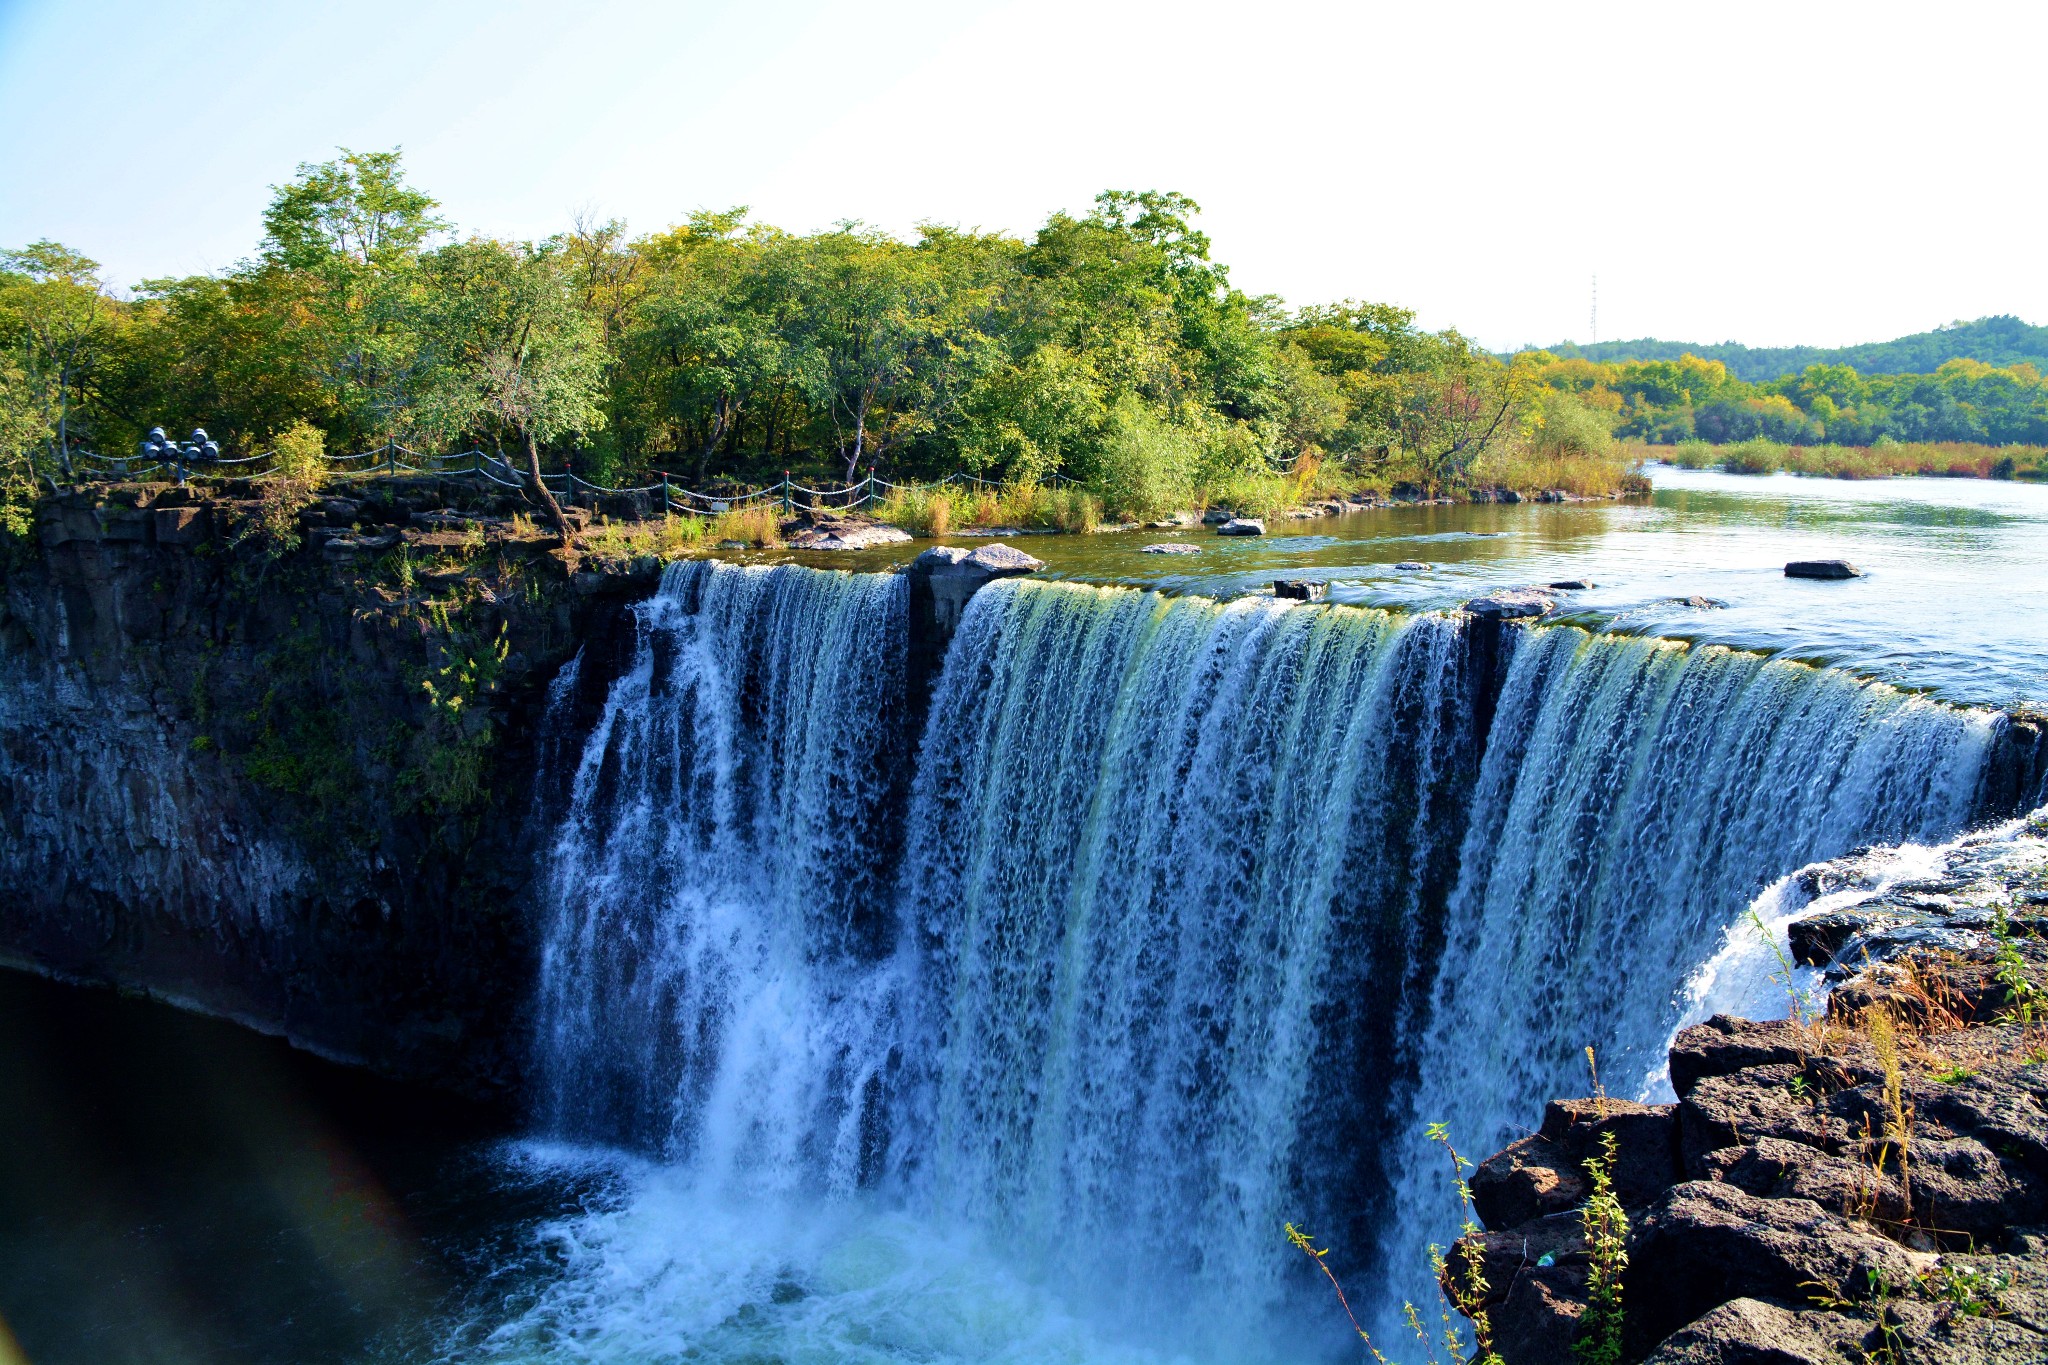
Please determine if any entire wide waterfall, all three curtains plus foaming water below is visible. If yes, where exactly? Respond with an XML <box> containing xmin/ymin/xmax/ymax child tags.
<box><xmin>504</xmin><ymin>565</ymin><xmax>1989</xmax><ymax>1359</ymax></box>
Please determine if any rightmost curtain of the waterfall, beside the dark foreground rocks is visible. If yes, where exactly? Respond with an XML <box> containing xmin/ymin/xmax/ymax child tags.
<box><xmin>1380</xmin><ymin>626</ymin><xmax>1991</xmax><ymax>1332</ymax></box>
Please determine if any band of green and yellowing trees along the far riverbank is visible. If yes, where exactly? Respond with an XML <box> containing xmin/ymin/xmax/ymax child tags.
<box><xmin>0</xmin><ymin>151</ymin><xmax>2048</xmax><ymax>532</ymax></box>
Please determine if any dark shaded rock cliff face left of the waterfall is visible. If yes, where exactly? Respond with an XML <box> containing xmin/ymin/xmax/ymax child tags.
<box><xmin>0</xmin><ymin>481</ymin><xmax>653</xmax><ymax>1093</ymax></box>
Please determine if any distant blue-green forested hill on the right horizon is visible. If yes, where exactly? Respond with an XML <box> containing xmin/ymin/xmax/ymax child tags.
<box><xmin>1546</xmin><ymin>315</ymin><xmax>2048</xmax><ymax>383</ymax></box>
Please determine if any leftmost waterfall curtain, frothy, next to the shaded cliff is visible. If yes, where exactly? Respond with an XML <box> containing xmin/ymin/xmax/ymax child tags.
<box><xmin>539</xmin><ymin>563</ymin><xmax>907</xmax><ymax>1187</ymax></box>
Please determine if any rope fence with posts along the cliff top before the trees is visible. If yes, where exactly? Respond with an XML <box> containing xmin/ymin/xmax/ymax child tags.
<box><xmin>59</xmin><ymin>440</ymin><xmax>1079</xmax><ymax>516</ymax></box>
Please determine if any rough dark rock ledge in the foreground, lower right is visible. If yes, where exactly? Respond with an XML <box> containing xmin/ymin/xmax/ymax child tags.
<box><xmin>1452</xmin><ymin>812</ymin><xmax>2048</xmax><ymax>1365</ymax></box>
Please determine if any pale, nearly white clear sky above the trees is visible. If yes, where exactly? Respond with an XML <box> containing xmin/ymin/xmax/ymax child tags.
<box><xmin>0</xmin><ymin>0</ymin><xmax>2048</xmax><ymax>346</ymax></box>
